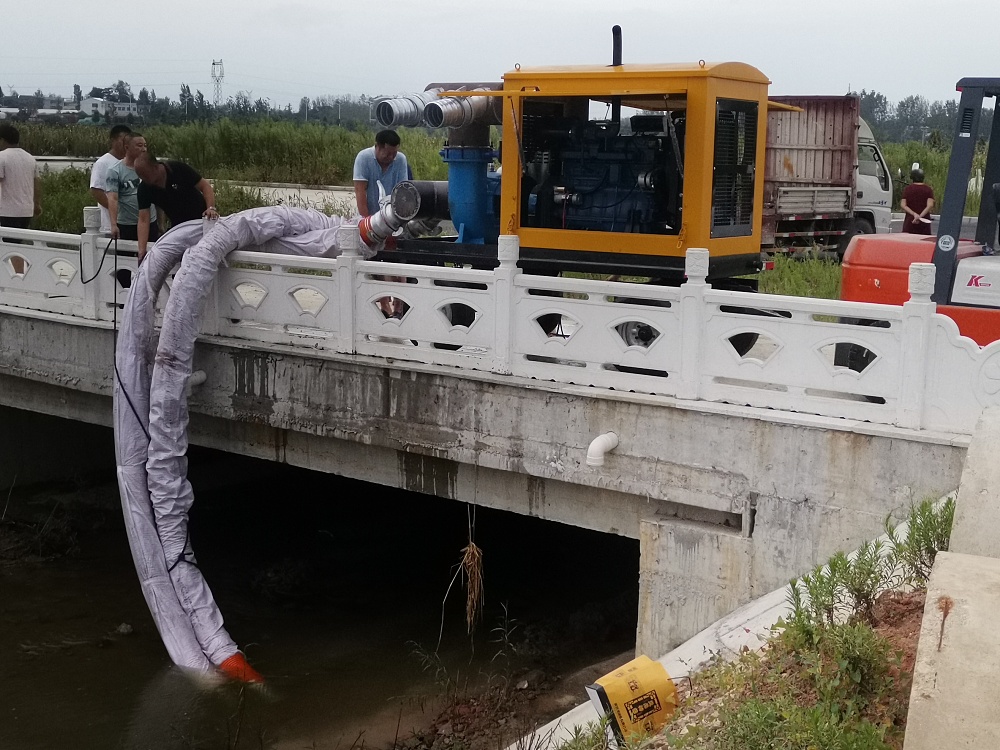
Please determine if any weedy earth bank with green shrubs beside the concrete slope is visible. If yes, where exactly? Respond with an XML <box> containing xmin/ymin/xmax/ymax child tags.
<box><xmin>561</xmin><ymin>500</ymin><xmax>955</xmax><ymax>750</ymax></box>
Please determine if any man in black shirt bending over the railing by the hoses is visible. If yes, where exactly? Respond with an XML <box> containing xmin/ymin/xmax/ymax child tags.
<box><xmin>135</xmin><ymin>153</ymin><xmax>219</xmax><ymax>261</ymax></box>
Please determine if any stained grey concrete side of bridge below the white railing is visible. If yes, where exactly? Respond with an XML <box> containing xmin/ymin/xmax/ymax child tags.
<box><xmin>0</xmin><ymin>311</ymin><xmax>968</xmax><ymax>656</ymax></box>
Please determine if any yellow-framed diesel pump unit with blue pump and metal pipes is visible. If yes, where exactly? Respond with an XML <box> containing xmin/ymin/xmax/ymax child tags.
<box><xmin>362</xmin><ymin>27</ymin><xmax>769</xmax><ymax>287</ymax></box>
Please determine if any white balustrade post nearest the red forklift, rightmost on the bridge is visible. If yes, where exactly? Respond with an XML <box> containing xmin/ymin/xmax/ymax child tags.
<box><xmin>896</xmin><ymin>263</ymin><xmax>937</xmax><ymax>429</ymax></box>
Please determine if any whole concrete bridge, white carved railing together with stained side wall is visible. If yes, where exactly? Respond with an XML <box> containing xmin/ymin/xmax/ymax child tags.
<box><xmin>0</xmin><ymin>219</ymin><xmax>1000</xmax><ymax>654</ymax></box>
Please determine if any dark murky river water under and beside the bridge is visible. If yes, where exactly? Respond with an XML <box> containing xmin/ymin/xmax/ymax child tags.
<box><xmin>0</xmin><ymin>449</ymin><xmax>638</xmax><ymax>750</ymax></box>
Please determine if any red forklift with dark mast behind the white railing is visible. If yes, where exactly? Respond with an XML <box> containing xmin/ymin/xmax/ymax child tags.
<box><xmin>837</xmin><ymin>78</ymin><xmax>1000</xmax><ymax>346</ymax></box>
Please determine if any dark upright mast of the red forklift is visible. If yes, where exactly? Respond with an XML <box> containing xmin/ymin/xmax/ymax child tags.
<box><xmin>932</xmin><ymin>78</ymin><xmax>1000</xmax><ymax>305</ymax></box>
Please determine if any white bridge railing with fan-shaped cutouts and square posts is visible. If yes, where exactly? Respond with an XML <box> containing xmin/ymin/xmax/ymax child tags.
<box><xmin>0</xmin><ymin>222</ymin><xmax>1000</xmax><ymax>433</ymax></box>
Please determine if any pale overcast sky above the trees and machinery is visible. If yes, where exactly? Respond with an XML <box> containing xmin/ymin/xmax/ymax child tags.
<box><xmin>0</xmin><ymin>0</ymin><xmax>1000</xmax><ymax>108</ymax></box>
